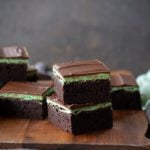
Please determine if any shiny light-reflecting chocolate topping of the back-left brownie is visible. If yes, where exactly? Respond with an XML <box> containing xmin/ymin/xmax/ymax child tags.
<box><xmin>0</xmin><ymin>46</ymin><xmax>29</xmax><ymax>59</ymax></box>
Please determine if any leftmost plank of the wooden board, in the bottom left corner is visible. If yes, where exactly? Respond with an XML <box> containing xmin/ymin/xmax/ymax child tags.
<box><xmin>0</xmin><ymin>118</ymin><xmax>29</xmax><ymax>149</ymax></box>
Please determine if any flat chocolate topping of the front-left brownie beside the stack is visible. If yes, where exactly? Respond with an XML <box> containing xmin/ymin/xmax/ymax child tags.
<box><xmin>0</xmin><ymin>81</ymin><xmax>49</xmax><ymax>96</ymax></box>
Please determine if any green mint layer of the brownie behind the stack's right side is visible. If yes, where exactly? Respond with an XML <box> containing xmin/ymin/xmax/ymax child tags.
<box><xmin>111</xmin><ymin>86</ymin><xmax>139</xmax><ymax>92</ymax></box>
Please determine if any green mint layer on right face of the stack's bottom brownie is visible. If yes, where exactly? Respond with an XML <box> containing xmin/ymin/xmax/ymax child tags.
<box><xmin>72</xmin><ymin>102</ymin><xmax>112</xmax><ymax>115</ymax></box>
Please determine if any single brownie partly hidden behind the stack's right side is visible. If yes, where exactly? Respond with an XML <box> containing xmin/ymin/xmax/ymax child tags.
<box><xmin>111</xmin><ymin>70</ymin><xmax>141</xmax><ymax>110</ymax></box>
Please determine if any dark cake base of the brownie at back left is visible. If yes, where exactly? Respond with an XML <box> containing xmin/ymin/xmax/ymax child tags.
<box><xmin>0</xmin><ymin>64</ymin><xmax>27</xmax><ymax>84</ymax></box>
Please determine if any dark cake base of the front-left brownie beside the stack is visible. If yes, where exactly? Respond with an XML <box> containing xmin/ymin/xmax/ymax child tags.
<box><xmin>0</xmin><ymin>99</ymin><xmax>47</xmax><ymax>119</ymax></box>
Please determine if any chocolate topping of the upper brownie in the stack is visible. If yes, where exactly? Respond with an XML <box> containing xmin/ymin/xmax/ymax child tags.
<box><xmin>53</xmin><ymin>60</ymin><xmax>109</xmax><ymax>77</ymax></box>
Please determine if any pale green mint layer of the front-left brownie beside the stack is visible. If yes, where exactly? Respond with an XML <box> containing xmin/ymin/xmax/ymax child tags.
<box><xmin>0</xmin><ymin>88</ymin><xmax>54</xmax><ymax>101</ymax></box>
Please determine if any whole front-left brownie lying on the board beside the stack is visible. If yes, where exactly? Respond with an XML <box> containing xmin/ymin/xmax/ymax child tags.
<box><xmin>0</xmin><ymin>81</ymin><xmax>53</xmax><ymax>119</ymax></box>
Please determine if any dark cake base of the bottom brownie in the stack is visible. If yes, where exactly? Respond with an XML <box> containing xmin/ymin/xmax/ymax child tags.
<box><xmin>48</xmin><ymin>104</ymin><xmax>113</xmax><ymax>135</ymax></box>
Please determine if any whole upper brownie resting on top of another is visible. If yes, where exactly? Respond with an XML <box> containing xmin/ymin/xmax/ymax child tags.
<box><xmin>53</xmin><ymin>60</ymin><xmax>110</xmax><ymax>104</ymax></box>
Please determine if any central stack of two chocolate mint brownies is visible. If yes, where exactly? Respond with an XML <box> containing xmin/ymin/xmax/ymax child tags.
<box><xmin>47</xmin><ymin>60</ymin><xmax>113</xmax><ymax>134</ymax></box>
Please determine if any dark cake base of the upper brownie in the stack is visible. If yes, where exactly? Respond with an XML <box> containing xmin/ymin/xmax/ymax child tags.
<box><xmin>54</xmin><ymin>78</ymin><xmax>110</xmax><ymax>104</ymax></box>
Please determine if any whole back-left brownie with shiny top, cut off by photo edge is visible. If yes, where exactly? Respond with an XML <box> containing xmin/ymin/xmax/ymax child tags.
<box><xmin>0</xmin><ymin>46</ymin><xmax>29</xmax><ymax>85</ymax></box>
